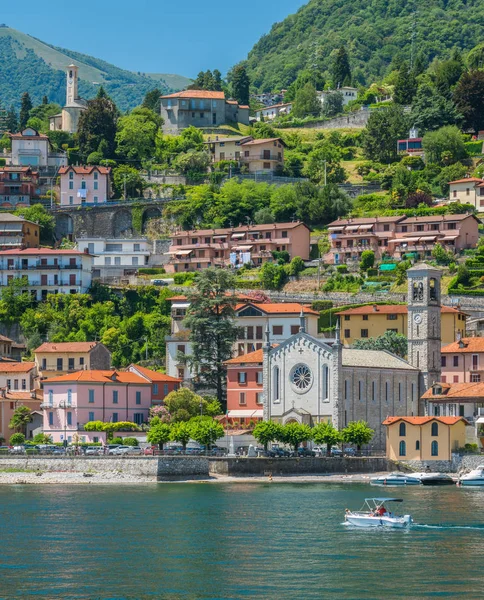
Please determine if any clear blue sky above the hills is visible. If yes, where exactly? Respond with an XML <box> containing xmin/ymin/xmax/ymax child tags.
<box><xmin>0</xmin><ymin>0</ymin><xmax>305</xmax><ymax>77</ymax></box>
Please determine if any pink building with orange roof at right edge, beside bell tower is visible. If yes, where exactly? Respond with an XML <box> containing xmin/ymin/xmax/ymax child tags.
<box><xmin>441</xmin><ymin>337</ymin><xmax>484</xmax><ymax>383</ymax></box>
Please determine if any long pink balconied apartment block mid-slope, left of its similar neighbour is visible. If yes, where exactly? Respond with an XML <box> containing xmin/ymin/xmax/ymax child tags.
<box><xmin>165</xmin><ymin>221</ymin><xmax>310</xmax><ymax>273</ymax></box>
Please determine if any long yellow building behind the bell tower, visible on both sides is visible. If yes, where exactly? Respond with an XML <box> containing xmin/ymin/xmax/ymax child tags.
<box><xmin>337</xmin><ymin>304</ymin><xmax>467</xmax><ymax>346</ymax></box>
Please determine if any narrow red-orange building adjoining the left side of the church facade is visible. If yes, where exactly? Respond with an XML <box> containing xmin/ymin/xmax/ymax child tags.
<box><xmin>225</xmin><ymin>349</ymin><xmax>264</xmax><ymax>426</ymax></box>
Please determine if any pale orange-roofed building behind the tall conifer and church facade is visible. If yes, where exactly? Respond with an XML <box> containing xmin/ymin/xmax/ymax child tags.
<box><xmin>165</xmin><ymin>296</ymin><xmax>319</xmax><ymax>379</ymax></box>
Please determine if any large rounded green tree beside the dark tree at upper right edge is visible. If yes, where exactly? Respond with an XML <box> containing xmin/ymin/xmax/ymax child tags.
<box><xmin>410</xmin><ymin>84</ymin><xmax>462</xmax><ymax>134</ymax></box>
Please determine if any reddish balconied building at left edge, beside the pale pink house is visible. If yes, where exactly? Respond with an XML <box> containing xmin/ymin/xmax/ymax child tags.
<box><xmin>0</xmin><ymin>167</ymin><xmax>39</xmax><ymax>208</ymax></box>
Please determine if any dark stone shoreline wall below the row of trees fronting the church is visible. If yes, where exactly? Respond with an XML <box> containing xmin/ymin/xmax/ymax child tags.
<box><xmin>209</xmin><ymin>457</ymin><xmax>395</xmax><ymax>476</ymax></box>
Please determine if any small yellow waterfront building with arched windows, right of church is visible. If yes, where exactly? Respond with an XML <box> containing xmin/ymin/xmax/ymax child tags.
<box><xmin>383</xmin><ymin>417</ymin><xmax>468</xmax><ymax>461</ymax></box>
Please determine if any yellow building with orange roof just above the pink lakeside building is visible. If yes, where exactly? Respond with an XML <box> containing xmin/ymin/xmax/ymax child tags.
<box><xmin>34</xmin><ymin>342</ymin><xmax>111</xmax><ymax>379</ymax></box>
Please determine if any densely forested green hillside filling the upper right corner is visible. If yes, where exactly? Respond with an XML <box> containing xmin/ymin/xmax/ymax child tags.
<box><xmin>247</xmin><ymin>0</ymin><xmax>484</xmax><ymax>91</ymax></box>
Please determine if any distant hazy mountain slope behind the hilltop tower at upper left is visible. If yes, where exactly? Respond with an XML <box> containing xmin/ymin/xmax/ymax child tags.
<box><xmin>0</xmin><ymin>25</ymin><xmax>190</xmax><ymax>110</ymax></box>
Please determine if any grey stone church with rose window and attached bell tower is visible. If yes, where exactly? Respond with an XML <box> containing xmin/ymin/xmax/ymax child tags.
<box><xmin>263</xmin><ymin>263</ymin><xmax>441</xmax><ymax>450</ymax></box>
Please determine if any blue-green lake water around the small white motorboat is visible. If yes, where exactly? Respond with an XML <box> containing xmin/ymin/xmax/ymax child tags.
<box><xmin>0</xmin><ymin>482</ymin><xmax>484</xmax><ymax>600</ymax></box>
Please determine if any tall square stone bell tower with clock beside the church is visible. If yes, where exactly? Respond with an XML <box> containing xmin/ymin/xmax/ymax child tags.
<box><xmin>407</xmin><ymin>263</ymin><xmax>442</xmax><ymax>408</ymax></box>
